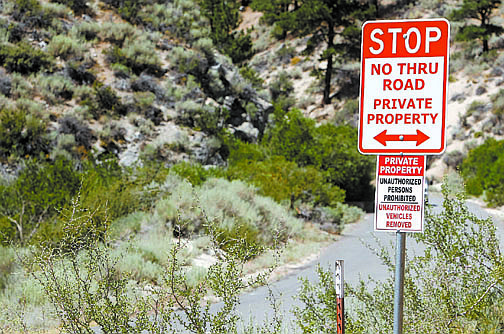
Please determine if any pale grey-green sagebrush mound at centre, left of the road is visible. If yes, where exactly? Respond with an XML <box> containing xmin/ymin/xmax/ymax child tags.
<box><xmin>156</xmin><ymin>174</ymin><xmax>302</xmax><ymax>247</ymax></box>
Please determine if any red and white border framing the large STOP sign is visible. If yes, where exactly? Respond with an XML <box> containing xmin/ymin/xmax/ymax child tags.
<box><xmin>358</xmin><ymin>18</ymin><xmax>450</xmax><ymax>155</ymax></box>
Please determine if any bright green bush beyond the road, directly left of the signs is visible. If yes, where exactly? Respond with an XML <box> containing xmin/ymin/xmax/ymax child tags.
<box><xmin>262</xmin><ymin>109</ymin><xmax>374</xmax><ymax>201</ymax></box>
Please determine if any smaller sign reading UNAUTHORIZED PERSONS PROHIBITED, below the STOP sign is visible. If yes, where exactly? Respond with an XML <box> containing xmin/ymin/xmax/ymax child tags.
<box><xmin>375</xmin><ymin>155</ymin><xmax>425</xmax><ymax>232</ymax></box>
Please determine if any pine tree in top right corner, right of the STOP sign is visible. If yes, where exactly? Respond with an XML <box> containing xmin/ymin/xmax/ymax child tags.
<box><xmin>451</xmin><ymin>0</ymin><xmax>504</xmax><ymax>52</ymax></box>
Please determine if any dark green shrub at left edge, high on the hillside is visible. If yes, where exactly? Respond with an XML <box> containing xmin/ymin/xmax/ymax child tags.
<box><xmin>0</xmin><ymin>42</ymin><xmax>52</xmax><ymax>74</ymax></box>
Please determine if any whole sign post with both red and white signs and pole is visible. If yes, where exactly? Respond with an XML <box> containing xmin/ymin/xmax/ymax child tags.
<box><xmin>358</xmin><ymin>19</ymin><xmax>450</xmax><ymax>334</ymax></box>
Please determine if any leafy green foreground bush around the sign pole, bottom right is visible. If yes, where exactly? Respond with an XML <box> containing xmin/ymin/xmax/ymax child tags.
<box><xmin>296</xmin><ymin>181</ymin><xmax>504</xmax><ymax>334</ymax></box>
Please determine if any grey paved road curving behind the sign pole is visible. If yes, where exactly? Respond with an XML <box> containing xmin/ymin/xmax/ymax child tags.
<box><xmin>234</xmin><ymin>194</ymin><xmax>504</xmax><ymax>323</ymax></box>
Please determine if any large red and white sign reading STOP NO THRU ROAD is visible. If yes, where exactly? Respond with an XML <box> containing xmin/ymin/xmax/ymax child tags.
<box><xmin>359</xmin><ymin>19</ymin><xmax>450</xmax><ymax>154</ymax></box>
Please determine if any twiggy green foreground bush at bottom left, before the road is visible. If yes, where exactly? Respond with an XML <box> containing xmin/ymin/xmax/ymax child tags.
<box><xmin>15</xmin><ymin>189</ymin><xmax>278</xmax><ymax>334</ymax></box>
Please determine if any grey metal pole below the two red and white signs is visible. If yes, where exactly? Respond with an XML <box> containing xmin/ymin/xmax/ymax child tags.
<box><xmin>393</xmin><ymin>231</ymin><xmax>406</xmax><ymax>334</ymax></box>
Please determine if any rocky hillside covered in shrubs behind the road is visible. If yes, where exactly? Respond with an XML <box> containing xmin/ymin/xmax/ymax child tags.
<box><xmin>0</xmin><ymin>0</ymin><xmax>504</xmax><ymax>331</ymax></box>
